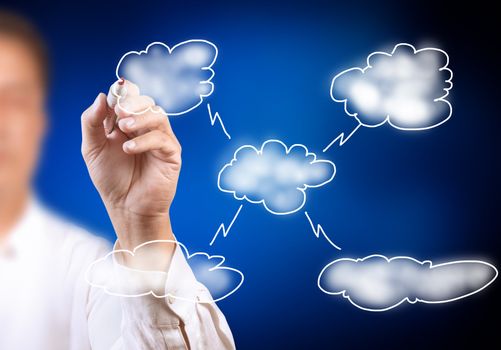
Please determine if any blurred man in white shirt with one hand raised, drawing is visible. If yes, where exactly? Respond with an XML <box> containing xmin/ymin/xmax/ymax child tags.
<box><xmin>0</xmin><ymin>12</ymin><xmax>234</xmax><ymax>350</ymax></box>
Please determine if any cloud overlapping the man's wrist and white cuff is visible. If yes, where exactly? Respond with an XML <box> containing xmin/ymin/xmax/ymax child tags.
<box><xmin>85</xmin><ymin>240</ymin><xmax>244</xmax><ymax>303</ymax></box>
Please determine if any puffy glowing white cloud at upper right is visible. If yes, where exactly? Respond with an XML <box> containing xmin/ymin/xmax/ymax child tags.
<box><xmin>330</xmin><ymin>43</ymin><xmax>452</xmax><ymax>131</ymax></box>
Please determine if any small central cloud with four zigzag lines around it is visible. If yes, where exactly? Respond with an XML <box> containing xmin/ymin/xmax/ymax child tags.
<box><xmin>218</xmin><ymin>140</ymin><xmax>336</xmax><ymax>215</ymax></box>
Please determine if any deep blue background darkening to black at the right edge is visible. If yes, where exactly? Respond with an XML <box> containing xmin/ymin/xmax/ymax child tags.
<box><xmin>2</xmin><ymin>1</ymin><xmax>501</xmax><ymax>349</ymax></box>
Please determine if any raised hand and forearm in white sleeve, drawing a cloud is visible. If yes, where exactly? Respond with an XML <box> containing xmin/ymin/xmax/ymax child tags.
<box><xmin>82</xmin><ymin>85</ymin><xmax>234</xmax><ymax>349</ymax></box>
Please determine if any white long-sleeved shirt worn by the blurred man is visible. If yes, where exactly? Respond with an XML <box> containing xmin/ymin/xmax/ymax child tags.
<box><xmin>0</xmin><ymin>201</ymin><xmax>235</xmax><ymax>350</ymax></box>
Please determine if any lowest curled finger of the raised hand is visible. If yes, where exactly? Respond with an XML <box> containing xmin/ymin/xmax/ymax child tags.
<box><xmin>123</xmin><ymin>130</ymin><xmax>181</xmax><ymax>161</ymax></box>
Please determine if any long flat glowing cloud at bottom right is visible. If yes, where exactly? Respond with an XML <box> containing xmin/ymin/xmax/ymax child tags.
<box><xmin>318</xmin><ymin>255</ymin><xmax>498</xmax><ymax>311</ymax></box>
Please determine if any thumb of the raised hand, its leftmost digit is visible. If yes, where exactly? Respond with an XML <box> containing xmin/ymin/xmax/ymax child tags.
<box><xmin>82</xmin><ymin>93</ymin><xmax>110</xmax><ymax>156</ymax></box>
